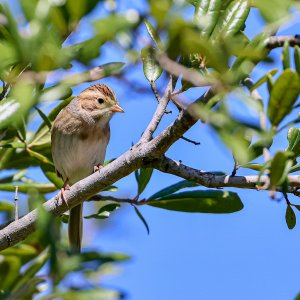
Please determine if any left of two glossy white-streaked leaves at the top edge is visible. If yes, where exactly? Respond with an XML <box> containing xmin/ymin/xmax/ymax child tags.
<box><xmin>194</xmin><ymin>0</ymin><xmax>222</xmax><ymax>38</ymax></box>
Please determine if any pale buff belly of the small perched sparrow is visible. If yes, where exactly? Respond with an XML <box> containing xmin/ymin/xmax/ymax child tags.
<box><xmin>52</xmin><ymin>134</ymin><xmax>107</xmax><ymax>185</ymax></box>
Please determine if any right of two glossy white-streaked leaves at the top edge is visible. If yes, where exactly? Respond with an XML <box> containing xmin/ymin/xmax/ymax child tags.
<box><xmin>211</xmin><ymin>0</ymin><xmax>250</xmax><ymax>39</ymax></box>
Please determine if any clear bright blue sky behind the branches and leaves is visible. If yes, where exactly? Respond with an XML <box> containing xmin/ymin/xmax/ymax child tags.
<box><xmin>1</xmin><ymin>1</ymin><xmax>300</xmax><ymax>300</ymax></box>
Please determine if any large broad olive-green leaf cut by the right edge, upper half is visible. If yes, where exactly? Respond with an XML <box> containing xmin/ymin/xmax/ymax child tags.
<box><xmin>268</xmin><ymin>69</ymin><xmax>300</xmax><ymax>126</ymax></box>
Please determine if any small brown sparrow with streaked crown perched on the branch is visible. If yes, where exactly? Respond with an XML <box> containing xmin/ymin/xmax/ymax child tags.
<box><xmin>51</xmin><ymin>84</ymin><xmax>124</xmax><ymax>253</ymax></box>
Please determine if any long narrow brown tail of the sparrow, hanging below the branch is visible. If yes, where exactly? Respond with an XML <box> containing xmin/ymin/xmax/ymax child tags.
<box><xmin>69</xmin><ymin>203</ymin><xmax>83</xmax><ymax>253</ymax></box>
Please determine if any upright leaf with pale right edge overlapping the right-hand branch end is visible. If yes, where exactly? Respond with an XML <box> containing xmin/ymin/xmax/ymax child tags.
<box><xmin>270</xmin><ymin>151</ymin><xmax>293</xmax><ymax>190</ymax></box>
